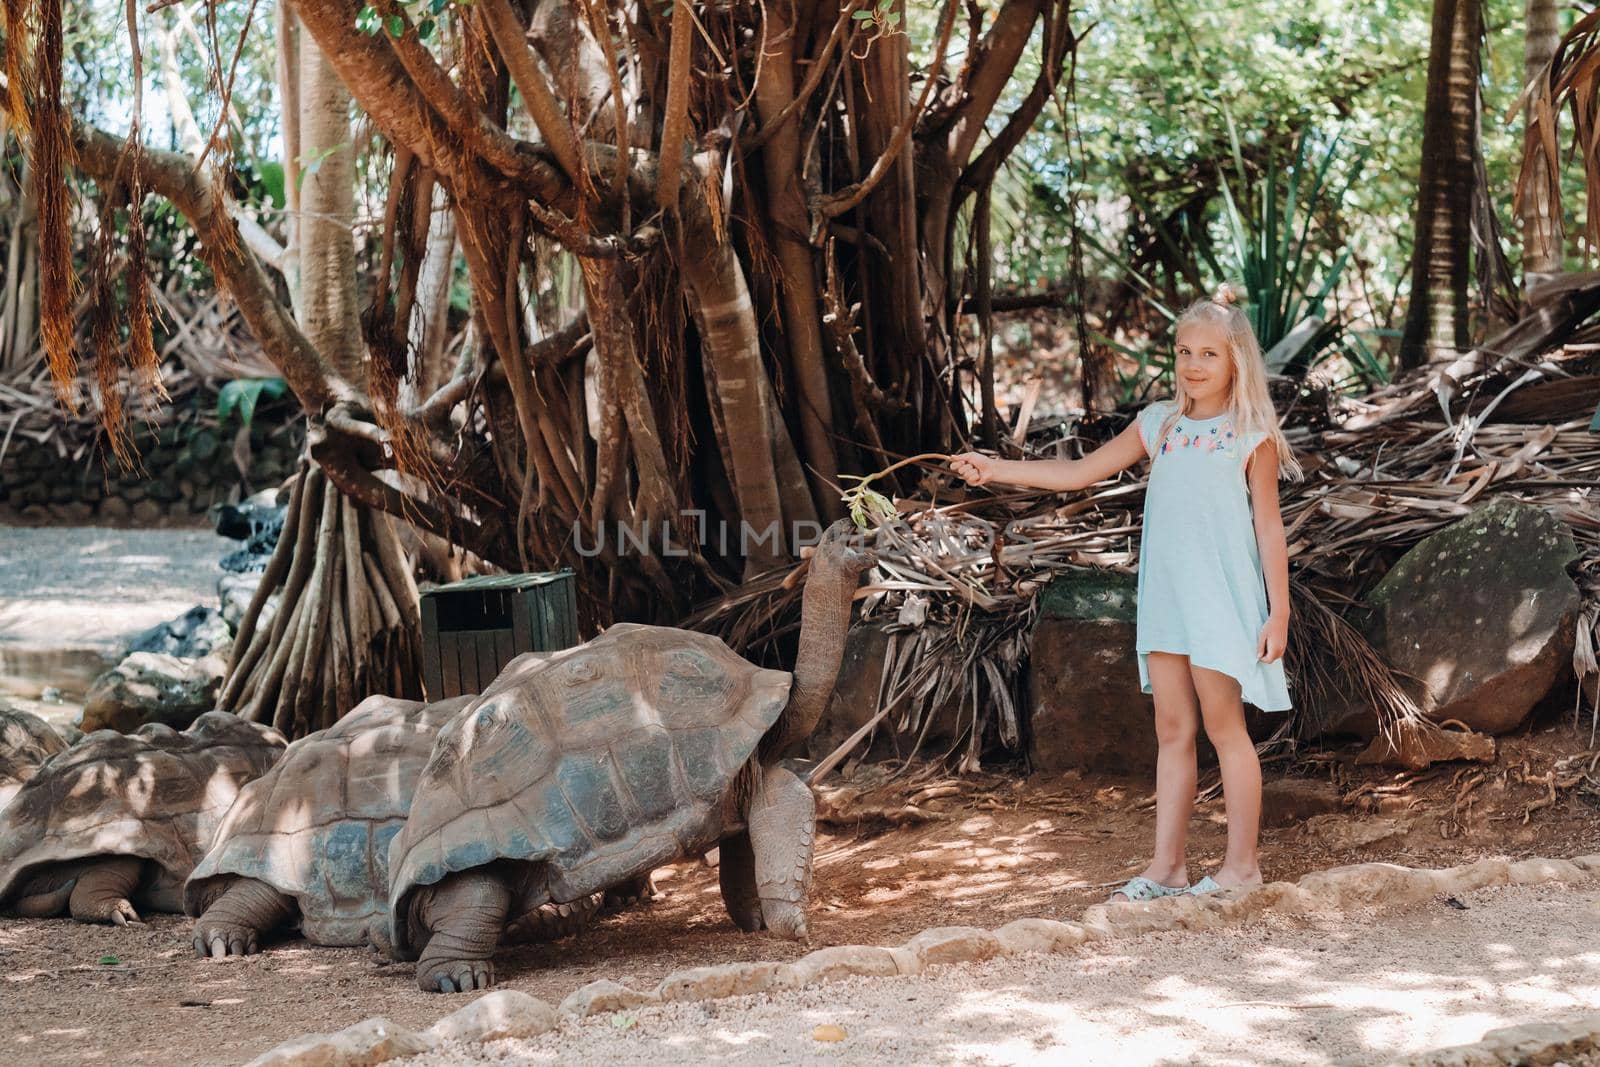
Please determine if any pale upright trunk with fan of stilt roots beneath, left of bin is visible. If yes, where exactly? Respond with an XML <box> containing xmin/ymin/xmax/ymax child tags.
<box><xmin>218</xmin><ymin>34</ymin><xmax>438</xmax><ymax>737</ymax></box>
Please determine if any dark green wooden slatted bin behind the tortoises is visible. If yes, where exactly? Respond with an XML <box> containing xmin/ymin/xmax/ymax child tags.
<box><xmin>422</xmin><ymin>569</ymin><xmax>578</xmax><ymax>701</ymax></box>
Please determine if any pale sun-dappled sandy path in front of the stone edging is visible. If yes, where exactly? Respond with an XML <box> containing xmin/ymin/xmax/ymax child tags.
<box><xmin>400</xmin><ymin>883</ymin><xmax>1600</xmax><ymax>1067</ymax></box>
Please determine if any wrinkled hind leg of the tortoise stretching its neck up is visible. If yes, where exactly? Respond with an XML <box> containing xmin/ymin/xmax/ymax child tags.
<box><xmin>413</xmin><ymin>869</ymin><xmax>510</xmax><ymax>993</ymax></box>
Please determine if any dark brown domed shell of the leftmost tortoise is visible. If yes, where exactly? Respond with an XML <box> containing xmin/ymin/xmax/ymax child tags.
<box><xmin>0</xmin><ymin>712</ymin><xmax>285</xmax><ymax>905</ymax></box>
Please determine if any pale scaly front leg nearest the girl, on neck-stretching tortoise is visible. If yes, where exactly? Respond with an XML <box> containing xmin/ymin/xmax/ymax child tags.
<box><xmin>748</xmin><ymin>766</ymin><xmax>816</xmax><ymax>941</ymax></box>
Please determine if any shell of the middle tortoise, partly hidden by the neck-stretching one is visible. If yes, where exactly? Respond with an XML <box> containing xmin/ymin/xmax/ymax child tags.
<box><xmin>184</xmin><ymin>696</ymin><xmax>475</xmax><ymax>945</ymax></box>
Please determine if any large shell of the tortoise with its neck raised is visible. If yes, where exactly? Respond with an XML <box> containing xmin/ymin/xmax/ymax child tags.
<box><xmin>389</xmin><ymin>624</ymin><xmax>790</xmax><ymax>955</ymax></box>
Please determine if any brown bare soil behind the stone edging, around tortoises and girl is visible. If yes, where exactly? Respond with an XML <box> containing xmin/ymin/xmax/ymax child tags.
<box><xmin>0</xmin><ymin>723</ymin><xmax>1600</xmax><ymax>1064</ymax></box>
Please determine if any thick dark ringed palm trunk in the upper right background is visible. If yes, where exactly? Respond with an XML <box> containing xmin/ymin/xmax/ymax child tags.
<box><xmin>1400</xmin><ymin>0</ymin><xmax>1483</xmax><ymax>368</ymax></box>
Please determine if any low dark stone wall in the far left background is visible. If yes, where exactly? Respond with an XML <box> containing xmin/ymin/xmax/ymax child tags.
<box><xmin>0</xmin><ymin>410</ymin><xmax>306</xmax><ymax>526</ymax></box>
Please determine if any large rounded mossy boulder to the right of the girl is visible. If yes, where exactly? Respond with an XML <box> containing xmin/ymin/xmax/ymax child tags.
<box><xmin>1357</xmin><ymin>496</ymin><xmax>1579</xmax><ymax>734</ymax></box>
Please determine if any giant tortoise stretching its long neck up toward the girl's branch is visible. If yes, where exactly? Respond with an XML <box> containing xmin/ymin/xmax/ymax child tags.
<box><xmin>389</xmin><ymin>522</ymin><xmax>874</xmax><ymax>992</ymax></box>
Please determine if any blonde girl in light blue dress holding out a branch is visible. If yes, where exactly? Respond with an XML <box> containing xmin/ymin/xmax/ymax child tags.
<box><xmin>950</xmin><ymin>286</ymin><xmax>1301</xmax><ymax>901</ymax></box>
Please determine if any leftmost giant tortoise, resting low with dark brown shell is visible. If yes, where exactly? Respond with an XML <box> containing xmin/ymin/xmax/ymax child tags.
<box><xmin>0</xmin><ymin>712</ymin><xmax>285</xmax><ymax>926</ymax></box>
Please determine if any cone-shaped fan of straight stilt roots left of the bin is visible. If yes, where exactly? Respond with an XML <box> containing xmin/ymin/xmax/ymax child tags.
<box><xmin>218</xmin><ymin>462</ymin><xmax>421</xmax><ymax>737</ymax></box>
